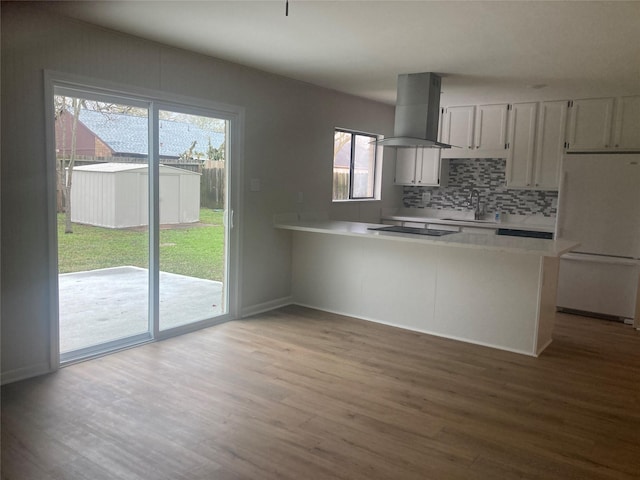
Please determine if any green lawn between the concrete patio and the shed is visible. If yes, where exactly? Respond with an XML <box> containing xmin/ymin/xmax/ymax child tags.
<box><xmin>58</xmin><ymin>208</ymin><xmax>224</xmax><ymax>281</ymax></box>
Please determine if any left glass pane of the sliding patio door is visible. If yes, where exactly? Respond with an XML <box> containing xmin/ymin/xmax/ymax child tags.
<box><xmin>54</xmin><ymin>94</ymin><xmax>149</xmax><ymax>358</ymax></box>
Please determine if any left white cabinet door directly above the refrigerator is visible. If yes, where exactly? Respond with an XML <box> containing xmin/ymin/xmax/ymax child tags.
<box><xmin>568</xmin><ymin>98</ymin><xmax>614</xmax><ymax>150</ymax></box>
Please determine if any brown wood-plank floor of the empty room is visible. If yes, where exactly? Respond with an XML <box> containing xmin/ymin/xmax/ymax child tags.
<box><xmin>2</xmin><ymin>306</ymin><xmax>640</xmax><ymax>480</ymax></box>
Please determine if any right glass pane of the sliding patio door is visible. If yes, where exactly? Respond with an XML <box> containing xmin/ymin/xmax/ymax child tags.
<box><xmin>158</xmin><ymin>110</ymin><xmax>228</xmax><ymax>330</ymax></box>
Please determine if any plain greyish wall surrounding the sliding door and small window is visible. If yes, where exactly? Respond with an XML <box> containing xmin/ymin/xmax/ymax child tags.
<box><xmin>1</xmin><ymin>3</ymin><xmax>401</xmax><ymax>379</ymax></box>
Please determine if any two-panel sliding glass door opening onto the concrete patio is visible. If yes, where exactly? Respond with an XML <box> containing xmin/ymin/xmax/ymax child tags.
<box><xmin>53</xmin><ymin>85</ymin><xmax>232</xmax><ymax>363</ymax></box>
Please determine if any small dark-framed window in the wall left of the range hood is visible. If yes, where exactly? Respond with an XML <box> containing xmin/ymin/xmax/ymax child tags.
<box><xmin>333</xmin><ymin>129</ymin><xmax>381</xmax><ymax>202</ymax></box>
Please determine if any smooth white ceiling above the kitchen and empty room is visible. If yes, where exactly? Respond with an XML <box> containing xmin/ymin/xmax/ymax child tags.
<box><xmin>43</xmin><ymin>0</ymin><xmax>640</xmax><ymax>105</ymax></box>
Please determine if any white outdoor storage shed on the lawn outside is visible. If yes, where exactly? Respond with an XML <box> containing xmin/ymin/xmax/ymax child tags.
<box><xmin>71</xmin><ymin>163</ymin><xmax>200</xmax><ymax>228</ymax></box>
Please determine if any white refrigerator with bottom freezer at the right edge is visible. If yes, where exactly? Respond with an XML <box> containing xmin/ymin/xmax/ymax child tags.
<box><xmin>556</xmin><ymin>153</ymin><xmax>640</xmax><ymax>327</ymax></box>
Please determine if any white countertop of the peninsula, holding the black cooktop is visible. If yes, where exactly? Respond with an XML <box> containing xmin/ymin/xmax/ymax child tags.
<box><xmin>274</xmin><ymin>215</ymin><xmax>579</xmax><ymax>257</ymax></box>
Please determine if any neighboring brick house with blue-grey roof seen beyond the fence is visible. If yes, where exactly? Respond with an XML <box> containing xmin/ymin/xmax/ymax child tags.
<box><xmin>55</xmin><ymin>109</ymin><xmax>224</xmax><ymax>161</ymax></box>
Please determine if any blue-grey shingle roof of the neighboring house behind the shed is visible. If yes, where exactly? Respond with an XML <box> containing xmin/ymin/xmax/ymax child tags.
<box><xmin>78</xmin><ymin>109</ymin><xmax>224</xmax><ymax>159</ymax></box>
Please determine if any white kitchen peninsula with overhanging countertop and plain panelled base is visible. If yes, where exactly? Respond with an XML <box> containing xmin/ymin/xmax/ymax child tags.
<box><xmin>275</xmin><ymin>214</ymin><xmax>578</xmax><ymax>356</ymax></box>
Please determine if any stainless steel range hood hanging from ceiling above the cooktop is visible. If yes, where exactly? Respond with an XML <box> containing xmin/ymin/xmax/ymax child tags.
<box><xmin>377</xmin><ymin>72</ymin><xmax>451</xmax><ymax>148</ymax></box>
